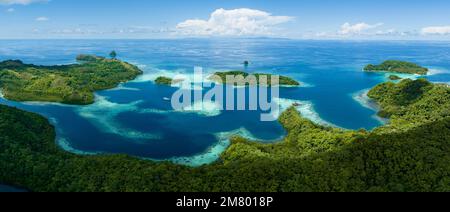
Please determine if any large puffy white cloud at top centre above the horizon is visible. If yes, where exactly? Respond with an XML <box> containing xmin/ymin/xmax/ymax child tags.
<box><xmin>176</xmin><ymin>8</ymin><xmax>293</xmax><ymax>36</ymax></box>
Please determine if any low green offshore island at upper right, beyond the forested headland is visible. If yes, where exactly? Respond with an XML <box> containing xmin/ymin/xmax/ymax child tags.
<box><xmin>364</xmin><ymin>60</ymin><xmax>429</xmax><ymax>75</ymax></box>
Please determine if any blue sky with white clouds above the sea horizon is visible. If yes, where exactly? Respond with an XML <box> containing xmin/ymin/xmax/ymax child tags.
<box><xmin>0</xmin><ymin>0</ymin><xmax>450</xmax><ymax>40</ymax></box>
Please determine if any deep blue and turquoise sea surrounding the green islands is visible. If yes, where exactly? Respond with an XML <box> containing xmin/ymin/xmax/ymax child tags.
<box><xmin>0</xmin><ymin>39</ymin><xmax>450</xmax><ymax>166</ymax></box>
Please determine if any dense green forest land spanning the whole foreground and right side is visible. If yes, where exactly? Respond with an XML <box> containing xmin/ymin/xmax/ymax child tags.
<box><xmin>0</xmin><ymin>79</ymin><xmax>450</xmax><ymax>192</ymax></box>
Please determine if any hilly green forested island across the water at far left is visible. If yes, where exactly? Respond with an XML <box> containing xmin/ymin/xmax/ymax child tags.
<box><xmin>0</xmin><ymin>55</ymin><xmax>143</xmax><ymax>105</ymax></box>
